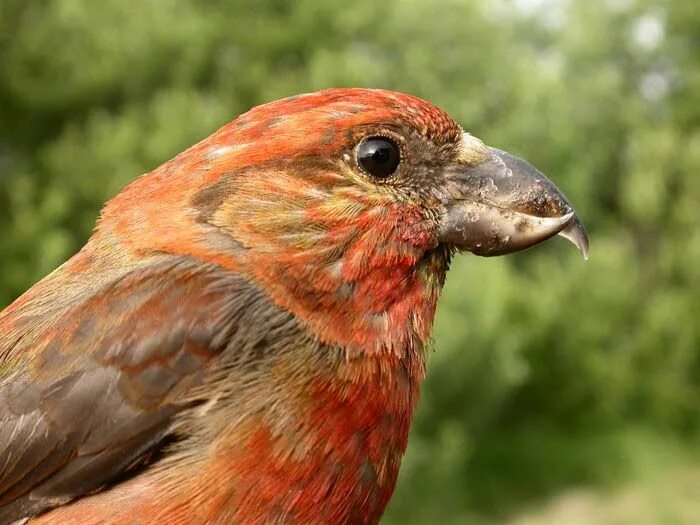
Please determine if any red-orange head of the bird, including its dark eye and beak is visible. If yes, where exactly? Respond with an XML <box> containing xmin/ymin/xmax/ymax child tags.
<box><xmin>100</xmin><ymin>89</ymin><xmax>588</xmax><ymax>351</ymax></box>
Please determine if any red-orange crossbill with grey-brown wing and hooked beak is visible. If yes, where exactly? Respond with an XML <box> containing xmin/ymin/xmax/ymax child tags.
<box><xmin>0</xmin><ymin>88</ymin><xmax>588</xmax><ymax>525</ymax></box>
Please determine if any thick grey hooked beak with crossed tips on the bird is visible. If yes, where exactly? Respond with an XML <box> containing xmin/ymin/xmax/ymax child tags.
<box><xmin>439</xmin><ymin>147</ymin><xmax>588</xmax><ymax>260</ymax></box>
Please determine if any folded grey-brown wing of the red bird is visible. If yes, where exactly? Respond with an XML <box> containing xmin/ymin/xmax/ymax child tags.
<box><xmin>0</xmin><ymin>255</ymin><xmax>242</xmax><ymax>523</ymax></box>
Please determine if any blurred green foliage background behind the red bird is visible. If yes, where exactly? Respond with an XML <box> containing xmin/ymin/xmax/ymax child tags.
<box><xmin>0</xmin><ymin>0</ymin><xmax>700</xmax><ymax>524</ymax></box>
